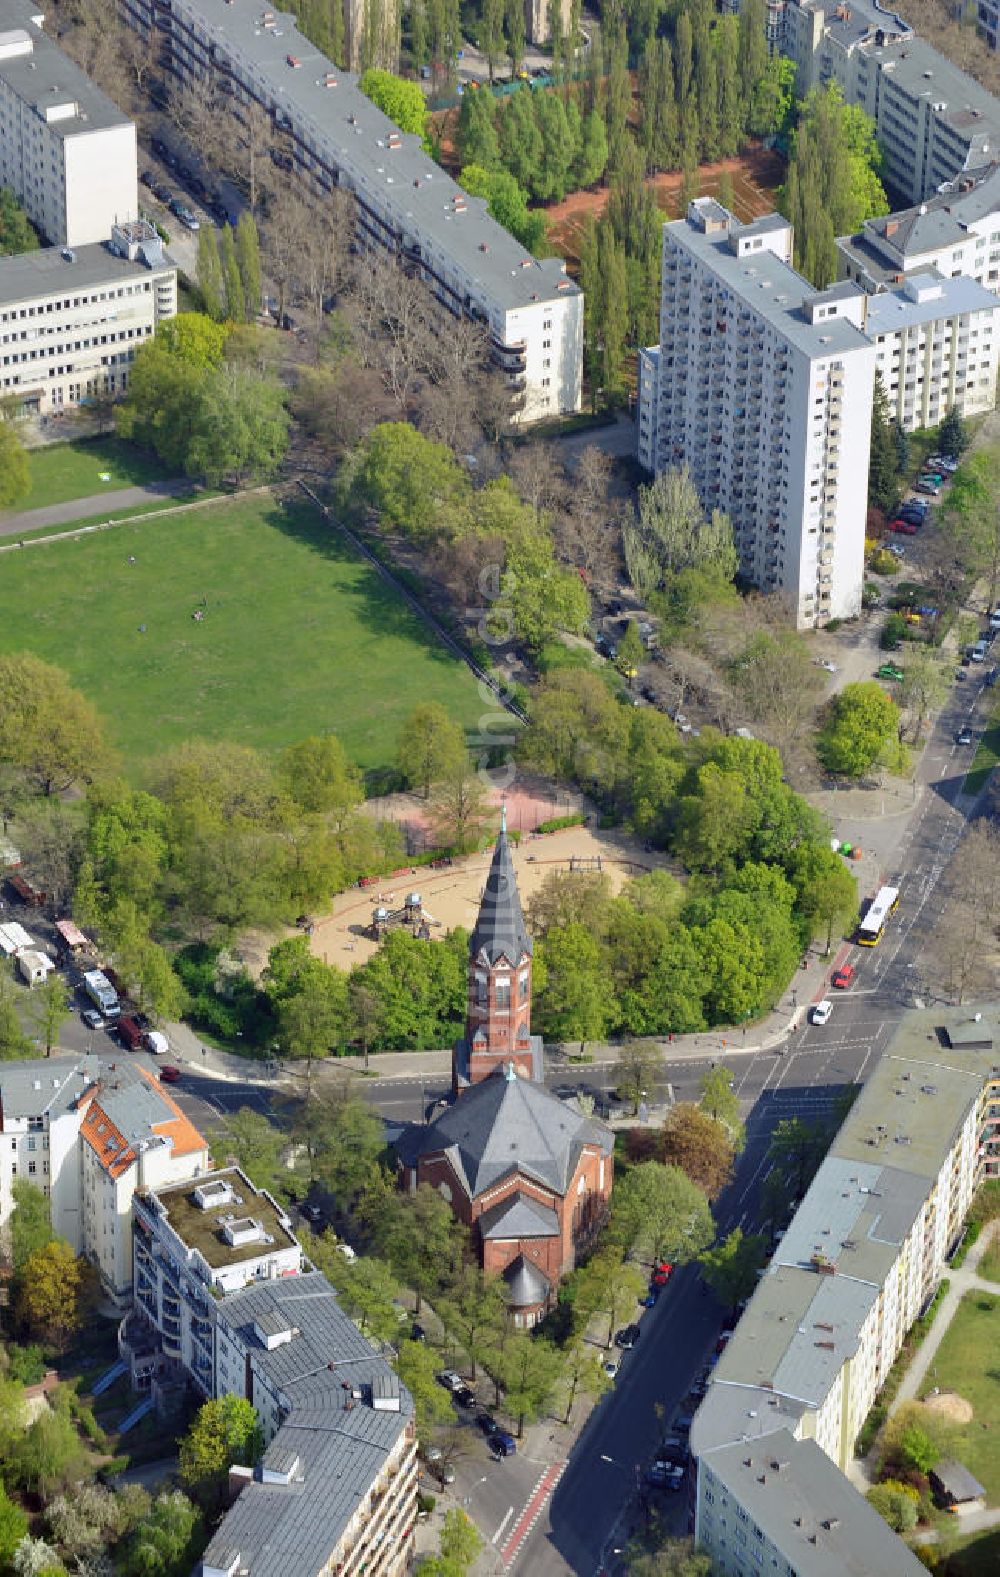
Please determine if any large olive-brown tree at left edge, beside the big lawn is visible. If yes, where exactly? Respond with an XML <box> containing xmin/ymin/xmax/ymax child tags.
<box><xmin>0</xmin><ymin>651</ymin><xmax>109</xmax><ymax>795</ymax></box>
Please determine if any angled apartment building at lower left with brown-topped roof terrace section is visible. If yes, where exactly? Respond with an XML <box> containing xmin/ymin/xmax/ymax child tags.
<box><xmin>128</xmin><ymin>1167</ymin><xmax>416</xmax><ymax>1577</ymax></box>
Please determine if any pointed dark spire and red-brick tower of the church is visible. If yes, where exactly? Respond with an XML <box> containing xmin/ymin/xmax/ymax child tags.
<box><xmin>453</xmin><ymin>806</ymin><xmax>541</xmax><ymax>1093</ymax></box>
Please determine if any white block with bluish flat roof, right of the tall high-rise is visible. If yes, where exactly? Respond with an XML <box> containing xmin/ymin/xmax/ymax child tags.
<box><xmin>864</xmin><ymin>271</ymin><xmax>1000</xmax><ymax>432</ymax></box>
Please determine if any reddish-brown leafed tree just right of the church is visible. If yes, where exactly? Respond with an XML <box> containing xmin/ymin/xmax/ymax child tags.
<box><xmin>612</xmin><ymin>1161</ymin><xmax>715</xmax><ymax>1265</ymax></box>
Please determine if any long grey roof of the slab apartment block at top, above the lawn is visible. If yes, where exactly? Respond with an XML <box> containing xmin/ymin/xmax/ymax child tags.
<box><xmin>159</xmin><ymin>0</ymin><xmax>577</xmax><ymax>309</ymax></box>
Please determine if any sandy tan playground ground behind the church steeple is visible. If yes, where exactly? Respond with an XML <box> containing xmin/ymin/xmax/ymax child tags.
<box><xmin>312</xmin><ymin>811</ymin><xmax>666</xmax><ymax>970</ymax></box>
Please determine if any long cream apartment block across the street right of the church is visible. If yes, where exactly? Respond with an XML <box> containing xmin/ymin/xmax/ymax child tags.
<box><xmin>691</xmin><ymin>1008</ymin><xmax>1000</xmax><ymax>1574</ymax></box>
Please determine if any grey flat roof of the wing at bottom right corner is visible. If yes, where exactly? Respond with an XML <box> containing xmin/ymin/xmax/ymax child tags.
<box><xmin>705</xmin><ymin>1429</ymin><xmax>926</xmax><ymax>1577</ymax></box>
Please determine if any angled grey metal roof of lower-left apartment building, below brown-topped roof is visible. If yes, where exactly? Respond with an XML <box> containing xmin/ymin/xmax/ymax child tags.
<box><xmin>203</xmin><ymin>1271</ymin><xmax>413</xmax><ymax>1577</ymax></box>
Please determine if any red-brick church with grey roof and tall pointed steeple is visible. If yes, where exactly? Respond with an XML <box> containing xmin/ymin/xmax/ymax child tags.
<box><xmin>396</xmin><ymin>815</ymin><xmax>614</xmax><ymax>1326</ymax></box>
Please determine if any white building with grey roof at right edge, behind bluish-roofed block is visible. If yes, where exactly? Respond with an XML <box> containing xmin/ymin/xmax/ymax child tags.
<box><xmin>838</xmin><ymin>164</ymin><xmax>1000</xmax><ymax>295</ymax></box>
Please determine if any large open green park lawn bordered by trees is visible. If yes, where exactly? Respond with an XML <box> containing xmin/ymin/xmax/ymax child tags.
<box><xmin>0</xmin><ymin>494</ymin><xmax>485</xmax><ymax>773</ymax></box>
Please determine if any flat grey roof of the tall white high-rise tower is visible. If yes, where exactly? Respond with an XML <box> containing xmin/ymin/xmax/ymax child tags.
<box><xmin>664</xmin><ymin>205</ymin><xmax>868</xmax><ymax>358</ymax></box>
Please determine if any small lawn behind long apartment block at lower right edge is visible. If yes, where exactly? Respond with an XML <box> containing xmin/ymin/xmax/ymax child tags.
<box><xmin>929</xmin><ymin>1292</ymin><xmax>1000</xmax><ymax>1506</ymax></box>
